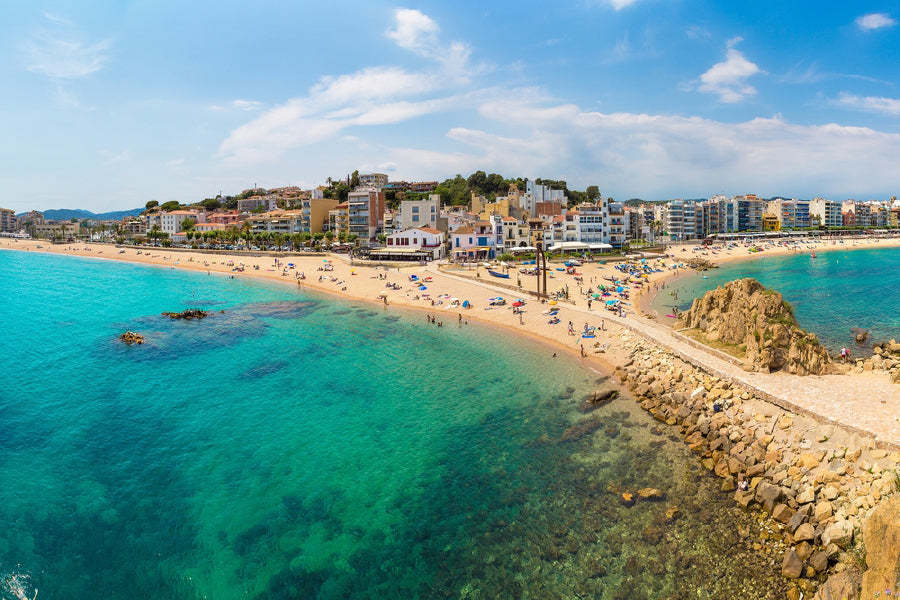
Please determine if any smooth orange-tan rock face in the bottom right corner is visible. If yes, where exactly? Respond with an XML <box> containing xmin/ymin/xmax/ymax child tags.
<box><xmin>862</xmin><ymin>497</ymin><xmax>900</xmax><ymax>598</ymax></box>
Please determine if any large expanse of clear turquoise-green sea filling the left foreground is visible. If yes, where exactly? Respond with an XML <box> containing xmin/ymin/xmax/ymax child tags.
<box><xmin>0</xmin><ymin>251</ymin><xmax>785</xmax><ymax>600</ymax></box>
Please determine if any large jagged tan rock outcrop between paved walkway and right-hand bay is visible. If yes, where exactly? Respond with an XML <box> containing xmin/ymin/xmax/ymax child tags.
<box><xmin>675</xmin><ymin>278</ymin><xmax>839</xmax><ymax>375</ymax></box>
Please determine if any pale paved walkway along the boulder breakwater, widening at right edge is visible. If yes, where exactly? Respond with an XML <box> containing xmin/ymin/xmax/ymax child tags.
<box><xmin>428</xmin><ymin>266</ymin><xmax>900</xmax><ymax>447</ymax></box>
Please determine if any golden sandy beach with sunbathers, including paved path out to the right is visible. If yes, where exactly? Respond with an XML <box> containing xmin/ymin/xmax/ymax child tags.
<box><xmin>10</xmin><ymin>234</ymin><xmax>900</xmax><ymax>446</ymax></box>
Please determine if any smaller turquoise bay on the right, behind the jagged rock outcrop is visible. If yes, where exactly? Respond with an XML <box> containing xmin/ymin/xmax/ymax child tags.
<box><xmin>653</xmin><ymin>248</ymin><xmax>900</xmax><ymax>353</ymax></box>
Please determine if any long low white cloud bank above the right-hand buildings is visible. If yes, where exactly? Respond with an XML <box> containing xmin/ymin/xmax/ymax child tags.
<box><xmin>378</xmin><ymin>94</ymin><xmax>900</xmax><ymax>199</ymax></box>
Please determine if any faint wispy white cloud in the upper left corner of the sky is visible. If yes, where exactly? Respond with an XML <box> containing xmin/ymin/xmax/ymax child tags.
<box><xmin>22</xmin><ymin>12</ymin><xmax>111</xmax><ymax>79</ymax></box>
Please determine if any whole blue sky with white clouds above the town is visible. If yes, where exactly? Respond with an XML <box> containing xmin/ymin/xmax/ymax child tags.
<box><xmin>0</xmin><ymin>0</ymin><xmax>900</xmax><ymax>212</ymax></box>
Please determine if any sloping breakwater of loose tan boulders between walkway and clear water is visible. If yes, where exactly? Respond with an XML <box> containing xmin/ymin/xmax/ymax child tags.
<box><xmin>617</xmin><ymin>334</ymin><xmax>900</xmax><ymax>600</ymax></box>
